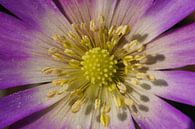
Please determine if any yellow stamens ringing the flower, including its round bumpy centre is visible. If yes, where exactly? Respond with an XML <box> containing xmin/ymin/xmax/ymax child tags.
<box><xmin>43</xmin><ymin>17</ymin><xmax>155</xmax><ymax>127</ymax></box>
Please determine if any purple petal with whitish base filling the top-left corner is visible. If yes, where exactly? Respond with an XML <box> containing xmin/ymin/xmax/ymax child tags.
<box><xmin>0</xmin><ymin>0</ymin><xmax>70</xmax><ymax>36</ymax></box>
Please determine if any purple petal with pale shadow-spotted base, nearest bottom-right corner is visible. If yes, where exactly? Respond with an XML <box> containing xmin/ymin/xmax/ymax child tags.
<box><xmin>129</xmin><ymin>89</ymin><xmax>192</xmax><ymax>129</ymax></box>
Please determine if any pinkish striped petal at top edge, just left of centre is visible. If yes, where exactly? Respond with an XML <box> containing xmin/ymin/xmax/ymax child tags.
<box><xmin>60</xmin><ymin>0</ymin><xmax>95</xmax><ymax>23</ymax></box>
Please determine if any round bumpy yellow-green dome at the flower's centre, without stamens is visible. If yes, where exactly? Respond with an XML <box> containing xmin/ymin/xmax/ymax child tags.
<box><xmin>81</xmin><ymin>47</ymin><xmax>117</xmax><ymax>86</ymax></box>
